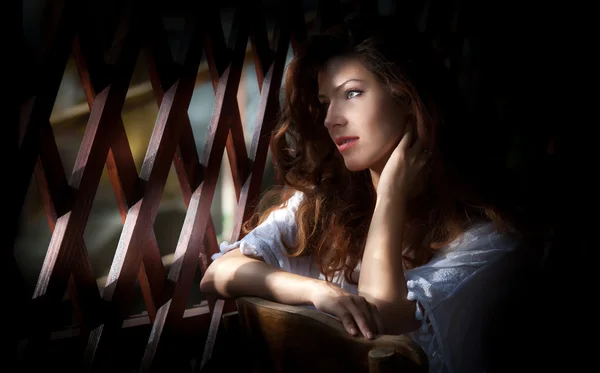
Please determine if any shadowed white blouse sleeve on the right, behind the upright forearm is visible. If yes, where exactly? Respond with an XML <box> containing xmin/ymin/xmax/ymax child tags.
<box><xmin>406</xmin><ymin>224</ymin><xmax>517</xmax><ymax>372</ymax></box>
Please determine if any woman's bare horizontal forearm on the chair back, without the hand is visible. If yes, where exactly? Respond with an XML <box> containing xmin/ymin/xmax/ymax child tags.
<box><xmin>200</xmin><ymin>252</ymin><xmax>319</xmax><ymax>305</ymax></box>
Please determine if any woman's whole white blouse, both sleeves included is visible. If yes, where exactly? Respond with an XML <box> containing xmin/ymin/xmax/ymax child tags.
<box><xmin>213</xmin><ymin>192</ymin><xmax>517</xmax><ymax>373</ymax></box>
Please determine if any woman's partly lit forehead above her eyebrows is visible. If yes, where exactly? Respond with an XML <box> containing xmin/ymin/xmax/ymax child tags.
<box><xmin>318</xmin><ymin>57</ymin><xmax>371</xmax><ymax>89</ymax></box>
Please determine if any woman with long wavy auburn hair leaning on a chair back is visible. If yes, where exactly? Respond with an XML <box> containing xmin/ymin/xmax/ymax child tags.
<box><xmin>201</xmin><ymin>17</ymin><xmax>518</xmax><ymax>372</ymax></box>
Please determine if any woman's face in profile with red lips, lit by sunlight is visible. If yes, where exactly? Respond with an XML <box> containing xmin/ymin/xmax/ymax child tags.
<box><xmin>318</xmin><ymin>57</ymin><xmax>409</xmax><ymax>172</ymax></box>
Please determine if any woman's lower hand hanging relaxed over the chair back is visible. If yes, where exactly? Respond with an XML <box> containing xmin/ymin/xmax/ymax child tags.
<box><xmin>311</xmin><ymin>281</ymin><xmax>383</xmax><ymax>339</ymax></box>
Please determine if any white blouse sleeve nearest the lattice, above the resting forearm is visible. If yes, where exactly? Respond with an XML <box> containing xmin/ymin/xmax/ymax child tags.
<box><xmin>212</xmin><ymin>192</ymin><xmax>308</xmax><ymax>274</ymax></box>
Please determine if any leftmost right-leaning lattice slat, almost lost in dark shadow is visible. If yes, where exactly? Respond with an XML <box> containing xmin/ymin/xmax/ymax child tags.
<box><xmin>11</xmin><ymin>0</ymin><xmax>77</xmax><ymax>364</ymax></box>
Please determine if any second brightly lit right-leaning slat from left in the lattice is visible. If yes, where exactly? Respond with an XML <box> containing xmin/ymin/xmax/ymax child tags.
<box><xmin>84</xmin><ymin>10</ymin><xmax>201</xmax><ymax>369</ymax></box>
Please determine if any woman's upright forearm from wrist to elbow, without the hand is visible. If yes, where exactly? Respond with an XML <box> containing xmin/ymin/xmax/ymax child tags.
<box><xmin>358</xmin><ymin>196</ymin><xmax>416</xmax><ymax>334</ymax></box>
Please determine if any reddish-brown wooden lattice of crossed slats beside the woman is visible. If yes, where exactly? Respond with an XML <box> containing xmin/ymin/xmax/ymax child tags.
<box><xmin>11</xmin><ymin>0</ymin><xmax>468</xmax><ymax>371</ymax></box>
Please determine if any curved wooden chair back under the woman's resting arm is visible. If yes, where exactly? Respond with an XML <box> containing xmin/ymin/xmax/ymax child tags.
<box><xmin>218</xmin><ymin>297</ymin><xmax>428</xmax><ymax>373</ymax></box>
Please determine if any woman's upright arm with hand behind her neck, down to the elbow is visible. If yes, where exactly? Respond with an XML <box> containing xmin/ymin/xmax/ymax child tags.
<box><xmin>358</xmin><ymin>133</ymin><xmax>427</xmax><ymax>334</ymax></box>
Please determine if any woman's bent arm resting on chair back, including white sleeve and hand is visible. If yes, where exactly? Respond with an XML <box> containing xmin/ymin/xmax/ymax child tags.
<box><xmin>200</xmin><ymin>196</ymin><xmax>390</xmax><ymax>338</ymax></box>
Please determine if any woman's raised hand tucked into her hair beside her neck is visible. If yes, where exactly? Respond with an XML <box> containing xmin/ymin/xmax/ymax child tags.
<box><xmin>377</xmin><ymin>132</ymin><xmax>430</xmax><ymax>198</ymax></box>
